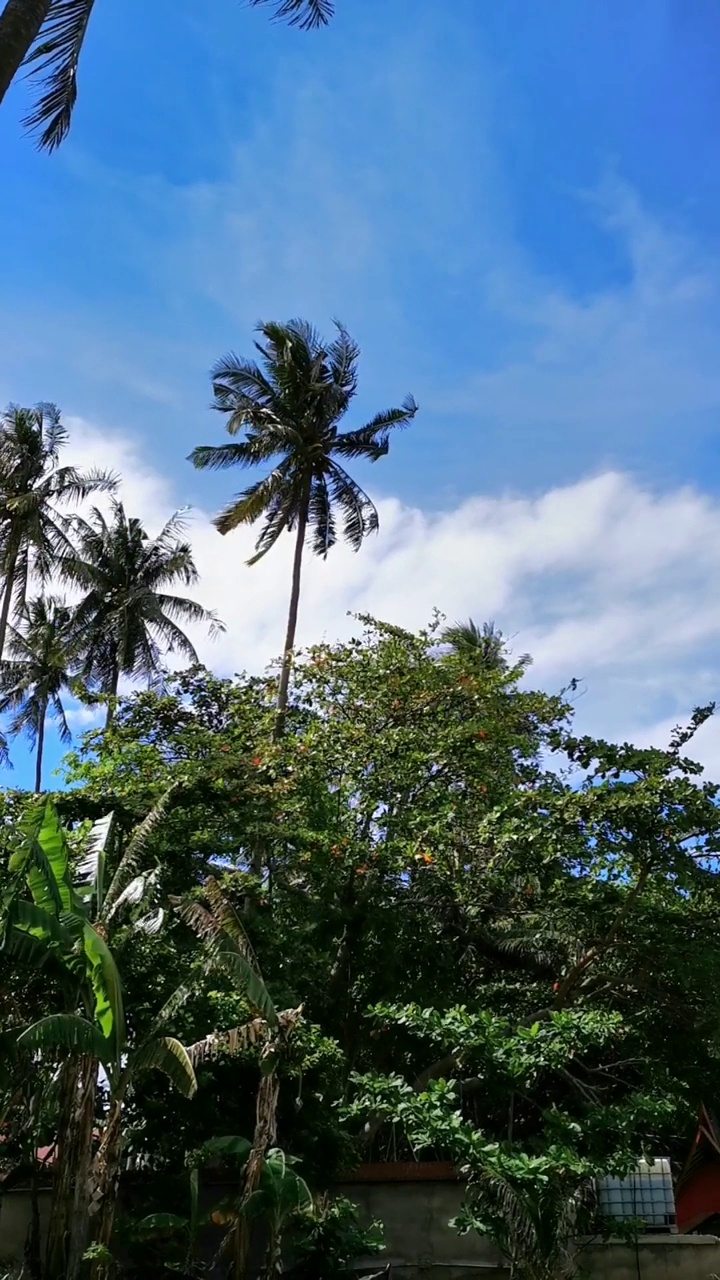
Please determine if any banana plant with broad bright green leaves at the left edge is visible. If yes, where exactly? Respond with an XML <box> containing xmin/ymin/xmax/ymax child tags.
<box><xmin>0</xmin><ymin>796</ymin><xmax>196</xmax><ymax>1280</ymax></box>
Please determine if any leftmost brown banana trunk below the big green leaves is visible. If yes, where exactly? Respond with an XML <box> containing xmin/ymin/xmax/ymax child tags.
<box><xmin>46</xmin><ymin>1057</ymin><xmax>97</xmax><ymax>1280</ymax></box>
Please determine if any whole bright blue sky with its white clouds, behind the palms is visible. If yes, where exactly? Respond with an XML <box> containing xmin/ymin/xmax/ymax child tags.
<box><xmin>0</xmin><ymin>0</ymin><xmax>720</xmax><ymax>777</ymax></box>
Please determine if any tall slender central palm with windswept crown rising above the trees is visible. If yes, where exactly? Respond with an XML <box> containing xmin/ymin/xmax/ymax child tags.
<box><xmin>190</xmin><ymin>320</ymin><xmax>418</xmax><ymax>717</ymax></box>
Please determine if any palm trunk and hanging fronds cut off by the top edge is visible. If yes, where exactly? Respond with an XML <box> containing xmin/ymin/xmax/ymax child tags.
<box><xmin>0</xmin><ymin>0</ymin><xmax>334</xmax><ymax>151</ymax></box>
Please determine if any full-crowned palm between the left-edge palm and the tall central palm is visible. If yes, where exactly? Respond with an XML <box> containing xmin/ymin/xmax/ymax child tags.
<box><xmin>59</xmin><ymin>500</ymin><xmax>222</xmax><ymax>722</ymax></box>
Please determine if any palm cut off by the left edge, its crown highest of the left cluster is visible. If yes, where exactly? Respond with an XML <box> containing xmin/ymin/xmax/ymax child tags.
<box><xmin>0</xmin><ymin>404</ymin><xmax>118</xmax><ymax>658</ymax></box>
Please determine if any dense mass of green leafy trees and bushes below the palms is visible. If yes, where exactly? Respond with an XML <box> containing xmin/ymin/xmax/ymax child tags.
<box><xmin>0</xmin><ymin>620</ymin><xmax>720</xmax><ymax>1280</ymax></box>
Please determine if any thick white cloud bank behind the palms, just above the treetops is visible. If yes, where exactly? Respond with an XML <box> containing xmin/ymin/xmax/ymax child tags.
<box><xmin>60</xmin><ymin>422</ymin><xmax>720</xmax><ymax>767</ymax></box>
